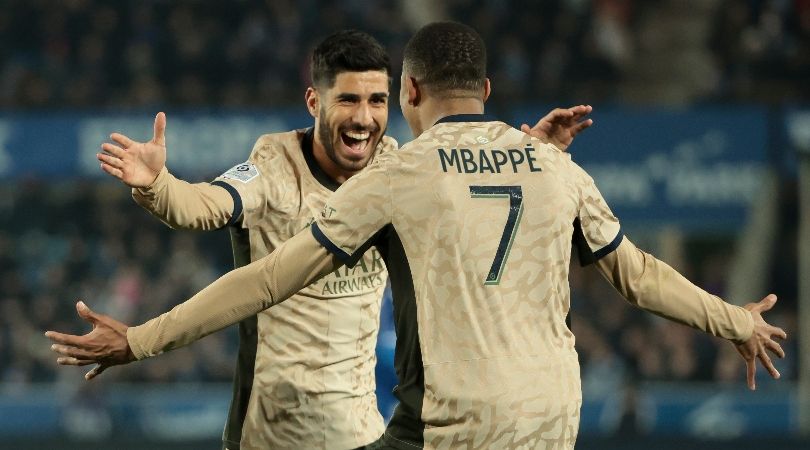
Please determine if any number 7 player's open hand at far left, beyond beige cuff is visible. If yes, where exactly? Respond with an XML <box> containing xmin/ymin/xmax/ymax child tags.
<box><xmin>45</xmin><ymin>302</ymin><xmax>135</xmax><ymax>380</ymax></box>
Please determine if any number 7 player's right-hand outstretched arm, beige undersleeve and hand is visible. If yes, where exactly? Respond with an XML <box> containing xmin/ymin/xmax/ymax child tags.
<box><xmin>597</xmin><ymin>237</ymin><xmax>787</xmax><ymax>389</ymax></box>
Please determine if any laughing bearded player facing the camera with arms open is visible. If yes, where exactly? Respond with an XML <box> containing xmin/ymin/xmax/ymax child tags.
<box><xmin>91</xmin><ymin>31</ymin><xmax>592</xmax><ymax>450</ymax></box>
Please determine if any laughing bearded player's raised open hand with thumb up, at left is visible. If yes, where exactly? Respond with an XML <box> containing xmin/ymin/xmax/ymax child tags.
<box><xmin>96</xmin><ymin>112</ymin><xmax>166</xmax><ymax>187</ymax></box>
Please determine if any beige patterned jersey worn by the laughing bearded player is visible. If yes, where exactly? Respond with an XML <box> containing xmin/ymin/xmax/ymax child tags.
<box><xmin>214</xmin><ymin>130</ymin><xmax>397</xmax><ymax>450</ymax></box>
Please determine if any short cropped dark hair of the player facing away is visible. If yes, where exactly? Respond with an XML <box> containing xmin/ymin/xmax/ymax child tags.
<box><xmin>403</xmin><ymin>22</ymin><xmax>487</xmax><ymax>95</ymax></box>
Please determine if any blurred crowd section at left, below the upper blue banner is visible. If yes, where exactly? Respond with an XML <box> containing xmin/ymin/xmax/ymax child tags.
<box><xmin>0</xmin><ymin>182</ymin><xmax>235</xmax><ymax>382</ymax></box>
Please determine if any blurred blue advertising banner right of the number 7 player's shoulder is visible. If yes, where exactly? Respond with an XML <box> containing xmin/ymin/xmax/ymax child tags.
<box><xmin>513</xmin><ymin>108</ymin><xmax>769</xmax><ymax>228</ymax></box>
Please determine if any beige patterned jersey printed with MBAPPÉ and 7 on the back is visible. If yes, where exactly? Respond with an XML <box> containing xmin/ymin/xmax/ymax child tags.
<box><xmin>312</xmin><ymin>115</ymin><xmax>621</xmax><ymax>449</ymax></box>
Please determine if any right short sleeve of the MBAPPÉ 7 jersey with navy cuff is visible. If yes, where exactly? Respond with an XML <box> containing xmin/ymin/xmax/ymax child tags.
<box><xmin>573</xmin><ymin>166</ymin><xmax>624</xmax><ymax>266</ymax></box>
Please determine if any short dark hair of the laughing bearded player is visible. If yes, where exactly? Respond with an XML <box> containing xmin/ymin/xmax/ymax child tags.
<box><xmin>310</xmin><ymin>30</ymin><xmax>391</xmax><ymax>88</ymax></box>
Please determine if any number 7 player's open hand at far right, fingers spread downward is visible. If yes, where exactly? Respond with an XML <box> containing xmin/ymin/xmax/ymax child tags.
<box><xmin>735</xmin><ymin>294</ymin><xmax>787</xmax><ymax>391</ymax></box>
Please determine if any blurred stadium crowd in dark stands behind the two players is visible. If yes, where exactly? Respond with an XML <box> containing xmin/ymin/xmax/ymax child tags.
<box><xmin>0</xmin><ymin>0</ymin><xmax>810</xmax><ymax>396</ymax></box>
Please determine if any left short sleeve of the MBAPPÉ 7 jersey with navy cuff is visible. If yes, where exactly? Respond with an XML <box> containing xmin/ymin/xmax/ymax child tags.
<box><xmin>311</xmin><ymin>158</ymin><xmax>393</xmax><ymax>267</ymax></box>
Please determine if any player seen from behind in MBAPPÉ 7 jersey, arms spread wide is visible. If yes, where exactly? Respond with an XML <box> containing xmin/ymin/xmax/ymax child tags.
<box><xmin>46</xmin><ymin>22</ymin><xmax>786</xmax><ymax>449</ymax></box>
